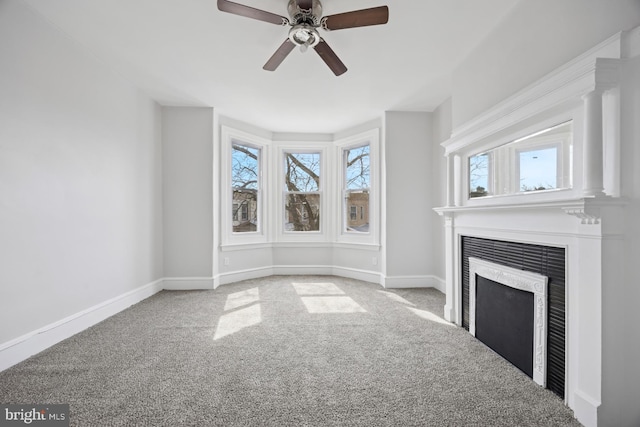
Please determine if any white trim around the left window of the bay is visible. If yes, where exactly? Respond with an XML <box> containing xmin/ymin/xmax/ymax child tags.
<box><xmin>220</xmin><ymin>125</ymin><xmax>270</xmax><ymax>246</ymax></box>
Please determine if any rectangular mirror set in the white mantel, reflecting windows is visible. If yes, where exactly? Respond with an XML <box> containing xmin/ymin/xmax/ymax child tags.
<box><xmin>468</xmin><ymin>122</ymin><xmax>573</xmax><ymax>198</ymax></box>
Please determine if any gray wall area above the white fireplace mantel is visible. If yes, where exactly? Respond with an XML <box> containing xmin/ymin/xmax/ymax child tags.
<box><xmin>453</xmin><ymin>0</ymin><xmax>640</xmax><ymax>128</ymax></box>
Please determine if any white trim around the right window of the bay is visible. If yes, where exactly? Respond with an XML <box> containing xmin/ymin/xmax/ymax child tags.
<box><xmin>333</xmin><ymin>129</ymin><xmax>381</xmax><ymax>245</ymax></box>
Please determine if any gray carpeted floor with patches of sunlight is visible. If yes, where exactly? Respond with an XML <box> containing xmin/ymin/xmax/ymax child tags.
<box><xmin>0</xmin><ymin>276</ymin><xmax>580</xmax><ymax>427</ymax></box>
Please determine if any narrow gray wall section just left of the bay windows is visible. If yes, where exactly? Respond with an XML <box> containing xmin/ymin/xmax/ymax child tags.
<box><xmin>162</xmin><ymin>107</ymin><xmax>213</xmax><ymax>278</ymax></box>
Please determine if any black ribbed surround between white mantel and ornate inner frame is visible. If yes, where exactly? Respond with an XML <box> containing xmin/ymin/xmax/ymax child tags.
<box><xmin>461</xmin><ymin>236</ymin><xmax>566</xmax><ymax>398</ymax></box>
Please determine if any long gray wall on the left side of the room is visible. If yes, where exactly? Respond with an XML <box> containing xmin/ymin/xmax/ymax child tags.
<box><xmin>0</xmin><ymin>1</ymin><xmax>163</xmax><ymax>343</ymax></box>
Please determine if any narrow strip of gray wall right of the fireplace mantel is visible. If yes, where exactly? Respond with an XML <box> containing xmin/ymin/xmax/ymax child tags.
<box><xmin>598</xmin><ymin>56</ymin><xmax>640</xmax><ymax>426</ymax></box>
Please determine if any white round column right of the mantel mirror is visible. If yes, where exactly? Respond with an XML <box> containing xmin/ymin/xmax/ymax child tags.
<box><xmin>582</xmin><ymin>90</ymin><xmax>604</xmax><ymax>196</ymax></box>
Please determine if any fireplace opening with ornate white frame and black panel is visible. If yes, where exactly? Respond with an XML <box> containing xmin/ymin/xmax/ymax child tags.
<box><xmin>469</xmin><ymin>257</ymin><xmax>548</xmax><ymax>386</ymax></box>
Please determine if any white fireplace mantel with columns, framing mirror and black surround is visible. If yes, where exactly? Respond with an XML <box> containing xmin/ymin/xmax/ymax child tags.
<box><xmin>434</xmin><ymin>25</ymin><xmax>640</xmax><ymax>427</ymax></box>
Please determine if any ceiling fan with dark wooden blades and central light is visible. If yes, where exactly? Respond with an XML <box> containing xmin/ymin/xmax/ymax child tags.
<box><xmin>218</xmin><ymin>0</ymin><xmax>389</xmax><ymax>76</ymax></box>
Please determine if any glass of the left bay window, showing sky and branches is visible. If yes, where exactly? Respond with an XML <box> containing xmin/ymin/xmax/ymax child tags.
<box><xmin>231</xmin><ymin>144</ymin><xmax>260</xmax><ymax>233</ymax></box>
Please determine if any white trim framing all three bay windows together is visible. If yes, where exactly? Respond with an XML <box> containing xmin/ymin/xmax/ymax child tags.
<box><xmin>219</xmin><ymin>125</ymin><xmax>382</xmax><ymax>252</ymax></box>
